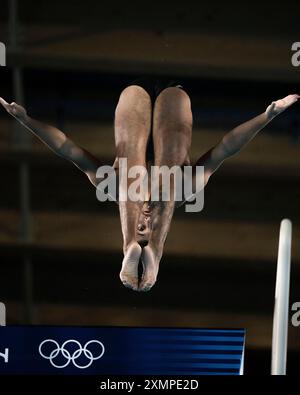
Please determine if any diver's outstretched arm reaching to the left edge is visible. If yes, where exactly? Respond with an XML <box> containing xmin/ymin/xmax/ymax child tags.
<box><xmin>0</xmin><ymin>97</ymin><xmax>101</xmax><ymax>186</ymax></box>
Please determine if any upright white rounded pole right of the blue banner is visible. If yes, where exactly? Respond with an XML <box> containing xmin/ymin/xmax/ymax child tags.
<box><xmin>271</xmin><ymin>219</ymin><xmax>292</xmax><ymax>375</ymax></box>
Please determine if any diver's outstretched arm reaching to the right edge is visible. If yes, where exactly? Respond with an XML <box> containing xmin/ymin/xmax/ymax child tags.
<box><xmin>196</xmin><ymin>94</ymin><xmax>300</xmax><ymax>183</ymax></box>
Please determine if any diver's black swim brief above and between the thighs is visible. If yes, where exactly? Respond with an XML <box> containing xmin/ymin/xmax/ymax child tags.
<box><xmin>130</xmin><ymin>77</ymin><xmax>183</xmax><ymax>104</ymax></box>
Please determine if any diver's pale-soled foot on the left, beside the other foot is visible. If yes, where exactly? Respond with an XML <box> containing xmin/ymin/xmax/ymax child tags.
<box><xmin>120</xmin><ymin>243</ymin><xmax>142</xmax><ymax>291</ymax></box>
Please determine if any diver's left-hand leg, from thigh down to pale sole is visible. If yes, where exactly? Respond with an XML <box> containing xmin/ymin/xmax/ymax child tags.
<box><xmin>114</xmin><ymin>85</ymin><xmax>152</xmax><ymax>289</ymax></box>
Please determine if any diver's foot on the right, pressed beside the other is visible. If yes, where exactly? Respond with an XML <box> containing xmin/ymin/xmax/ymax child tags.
<box><xmin>138</xmin><ymin>245</ymin><xmax>159</xmax><ymax>292</ymax></box>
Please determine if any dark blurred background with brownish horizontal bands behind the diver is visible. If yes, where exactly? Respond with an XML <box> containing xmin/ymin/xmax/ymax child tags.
<box><xmin>0</xmin><ymin>0</ymin><xmax>300</xmax><ymax>375</ymax></box>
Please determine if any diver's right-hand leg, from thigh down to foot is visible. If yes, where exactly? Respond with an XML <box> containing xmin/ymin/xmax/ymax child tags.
<box><xmin>139</xmin><ymin>87</ymin><xmax>193</xmax><ymax>291</ymax></box>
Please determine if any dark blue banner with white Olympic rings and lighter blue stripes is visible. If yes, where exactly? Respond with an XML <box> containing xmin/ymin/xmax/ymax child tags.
<box><xmin>0</xmin><ymin>326</ymin><xmax>245</xmax><ymax>375</ymax></box>
